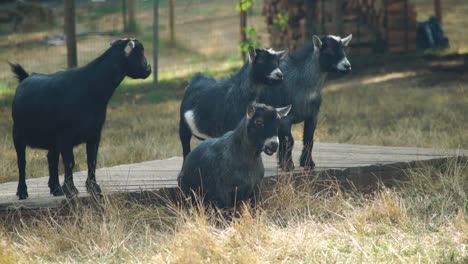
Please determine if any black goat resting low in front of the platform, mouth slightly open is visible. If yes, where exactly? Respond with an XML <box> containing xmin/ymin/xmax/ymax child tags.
<box><xmin>178</xmin><ymin>104</ymin><xmax>291</xmax><ymax>208</ymax></box>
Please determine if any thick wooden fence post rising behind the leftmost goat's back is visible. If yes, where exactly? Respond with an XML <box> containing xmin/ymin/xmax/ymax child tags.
<box><xmin>64</xmin><ymin>0</ymin><xmax>78</xmax><ymax>68</ymax></box>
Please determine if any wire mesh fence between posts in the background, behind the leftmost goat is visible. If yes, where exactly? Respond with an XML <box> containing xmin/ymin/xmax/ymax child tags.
<box><xmin>0</xmin><ymin>0</ymin><xmax>268</xmax><ymax>80</ymax></box>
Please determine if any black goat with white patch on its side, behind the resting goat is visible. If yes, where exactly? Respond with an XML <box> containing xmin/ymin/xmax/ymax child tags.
<box><xmin>179</xmin><ymin>47</ymin><xmax>285</xmax><ymax>158</ymax></box>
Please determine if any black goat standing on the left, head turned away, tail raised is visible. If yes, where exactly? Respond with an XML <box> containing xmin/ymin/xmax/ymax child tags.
<box><xmin>10</xmin><ymin>39</ymin><xmax>151</xmax><ymax>199</ymax></box>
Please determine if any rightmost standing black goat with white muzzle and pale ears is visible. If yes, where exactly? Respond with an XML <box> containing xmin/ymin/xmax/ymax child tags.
<box><xmin>258</xmin><ymin>35</ymin><xmax>352</xmax><ymax>171</ymax></box>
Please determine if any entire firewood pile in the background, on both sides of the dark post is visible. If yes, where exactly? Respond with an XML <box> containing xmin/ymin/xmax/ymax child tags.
<box><xmin>263</xmin><ymin>0</ymin><xmax>417</xmax><ymax>54</ymax></box>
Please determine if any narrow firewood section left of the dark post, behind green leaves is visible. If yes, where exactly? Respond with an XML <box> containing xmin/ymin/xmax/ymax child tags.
<box><xmin>263</xmin><ymin>0</ymin><xmax>306</xmax><ymax>50</ymax></box>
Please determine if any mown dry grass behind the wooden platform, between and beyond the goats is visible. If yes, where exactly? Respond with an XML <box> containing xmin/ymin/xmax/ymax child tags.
<box><xmin>0</xmin><ymin>65</ymin><xmax>468</xmax><ymax>182</ymax></box>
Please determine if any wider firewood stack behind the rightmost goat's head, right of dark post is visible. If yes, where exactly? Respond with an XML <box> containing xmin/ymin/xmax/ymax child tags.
<box><xmin>318</xmin><ymin>0</ymin><xmax>417</xmax><ymax>54</ymax></box>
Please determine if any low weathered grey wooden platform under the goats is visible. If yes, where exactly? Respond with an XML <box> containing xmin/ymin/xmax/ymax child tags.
<box><xmin>0</xmin><ymin>142</ymin><xmax>468</xmax><ymax>210</ymax></box>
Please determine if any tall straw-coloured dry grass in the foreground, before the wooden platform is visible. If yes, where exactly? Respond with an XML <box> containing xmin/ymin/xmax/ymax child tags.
<box><xmin>0</xmin><ymin>163</ymin><xmax>468</xmax><ymax>263</ymax></box>
